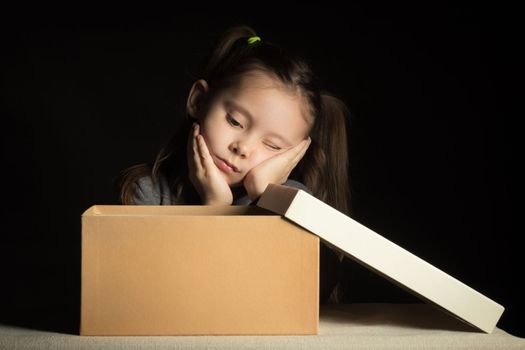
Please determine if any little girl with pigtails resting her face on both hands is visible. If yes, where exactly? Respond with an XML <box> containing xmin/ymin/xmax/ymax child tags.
<box><xmin>118</xmin><ymin>26</ymin><xmax>350</xmax><ymax>303</ymax></box>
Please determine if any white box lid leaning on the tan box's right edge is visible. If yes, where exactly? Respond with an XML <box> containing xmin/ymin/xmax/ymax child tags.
<box><xmin>257</xmin><ymin>184</ymin><xmax>504</xmax><ymax>333</ymax></box>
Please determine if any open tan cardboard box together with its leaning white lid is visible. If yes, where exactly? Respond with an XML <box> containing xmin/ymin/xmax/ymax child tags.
<box><xmin>80</xmin><ymin>185</ymin><xmax>504</xmax><ymax>335</ymax></box>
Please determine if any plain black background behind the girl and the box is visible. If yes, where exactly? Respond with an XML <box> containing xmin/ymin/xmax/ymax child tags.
<box><xmin>0</xmin><ymin>2</ymin><xmax>525</xmax><ymax>337</ymax></box>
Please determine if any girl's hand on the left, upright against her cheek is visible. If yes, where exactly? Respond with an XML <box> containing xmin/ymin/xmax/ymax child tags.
<box><xmin>187</xmin><ymin>123</ymin><xmax>233</xmax><ymax>205</ymax></box>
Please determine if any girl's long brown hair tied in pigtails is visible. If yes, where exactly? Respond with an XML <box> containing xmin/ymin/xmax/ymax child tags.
<box><xmin>117</xmin><ymin>25</ymin><xmax>350</xmax><ymax>214</ymax></box>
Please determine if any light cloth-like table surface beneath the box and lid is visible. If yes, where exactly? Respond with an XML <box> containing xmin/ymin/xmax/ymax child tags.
<box><xmin>0</xmin><ymin>303</ymin><xmax>525</xmax><ymax>349</ymax></box>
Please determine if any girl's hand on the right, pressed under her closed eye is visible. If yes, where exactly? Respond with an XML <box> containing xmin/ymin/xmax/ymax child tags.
<box><xmin>243</xmin><ymin>137</ymin><xmax>312</xmax><ymax>200</ymax></box>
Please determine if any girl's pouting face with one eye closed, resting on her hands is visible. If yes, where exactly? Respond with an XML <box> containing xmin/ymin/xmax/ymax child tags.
<box><xmin>190</xmin><ymin>73</ymin><xmax>310</xmax><ymax>186</ymax></box>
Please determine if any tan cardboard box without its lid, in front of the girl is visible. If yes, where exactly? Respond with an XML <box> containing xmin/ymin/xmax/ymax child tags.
<box><xmin>80</xmin><ymin>206</ymin><xmax>319</xmax><ymax>335</ymax></box>
